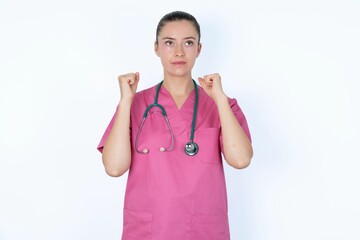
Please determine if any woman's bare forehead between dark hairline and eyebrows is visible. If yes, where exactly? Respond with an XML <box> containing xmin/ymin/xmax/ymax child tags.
<box><xmin>159</xmin><ymin>20</ymin><xmax>199</xmax><ymax>39</ymax></box>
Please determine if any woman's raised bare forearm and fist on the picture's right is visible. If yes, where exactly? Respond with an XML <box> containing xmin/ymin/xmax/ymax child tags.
<box><xmin>199</xmin><ymin>73</ymin><xmax>253</xmax><ymax>169</ymax></box>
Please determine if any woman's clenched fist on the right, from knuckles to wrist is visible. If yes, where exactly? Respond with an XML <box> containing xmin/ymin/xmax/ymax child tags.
<box><xmin>198</xmin><ymin>73</ymin><xmax>225</xmax><ymax>102</ymax></box>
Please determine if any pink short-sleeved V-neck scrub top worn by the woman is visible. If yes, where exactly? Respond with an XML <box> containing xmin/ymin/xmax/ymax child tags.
<box><xmin>98</xmin><ymin>83</ymin><xmax>251</xmax><ymax>240</ymax></box>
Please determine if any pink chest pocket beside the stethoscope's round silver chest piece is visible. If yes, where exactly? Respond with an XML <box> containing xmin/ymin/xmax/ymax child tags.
<box><xmin>193</xmin><ymin>128</ymin><xmax>221</xmax><ymax>164</ymax></box>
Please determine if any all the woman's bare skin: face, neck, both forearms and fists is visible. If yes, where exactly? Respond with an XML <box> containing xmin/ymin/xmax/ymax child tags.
<box><xmin>102</xmin><ymin>20</ymin><xmax>253</xmax><ymax>177</ymax></box>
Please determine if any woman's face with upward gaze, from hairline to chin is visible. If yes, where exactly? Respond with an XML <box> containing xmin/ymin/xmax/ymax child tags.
<box><xmin>155</xmin><ymin>20</ymin><xmax>201</xmax><ymax>77</ymax></box>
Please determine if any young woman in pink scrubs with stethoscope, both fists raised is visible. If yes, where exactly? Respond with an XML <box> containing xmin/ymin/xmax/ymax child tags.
<box><xmin>98</xmin><ymin>11</ymin><xmax>253</xmax><ymax>240</ymax></box>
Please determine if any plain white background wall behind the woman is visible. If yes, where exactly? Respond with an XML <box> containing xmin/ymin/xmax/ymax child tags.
<box><xmin>0</xmin><ymin>0</ymin><xmax>360</xmax><ymax>240</ymax></box>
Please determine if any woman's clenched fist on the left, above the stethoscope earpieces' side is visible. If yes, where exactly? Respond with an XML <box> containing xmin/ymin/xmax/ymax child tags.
<box><xmin>118</xmin><ymin>72</ymin><xmax>140</xmax><ymax>99</ymax></box>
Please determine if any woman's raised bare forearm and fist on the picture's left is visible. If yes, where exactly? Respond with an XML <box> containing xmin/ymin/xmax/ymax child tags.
<box><xmin>102</xmin><ymin>73</ymin><xmax>139</xmax><ymax>177</ymax></box>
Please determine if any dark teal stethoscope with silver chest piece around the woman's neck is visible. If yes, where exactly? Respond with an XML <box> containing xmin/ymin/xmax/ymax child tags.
<box><xmin>135</xmin><ymin>80</ymin><xmax>199</xmax><ymax>156</ymax></box>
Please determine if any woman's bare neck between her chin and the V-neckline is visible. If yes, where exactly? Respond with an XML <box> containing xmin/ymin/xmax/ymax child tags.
<box><xmin>163</xmin><ymin>77</ymin><xmax>194</xmax><ymax>96</ymax></box>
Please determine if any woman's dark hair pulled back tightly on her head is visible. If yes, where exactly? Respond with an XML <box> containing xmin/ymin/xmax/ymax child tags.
<box><xmin>156</xmin><ymin>11</ymin><xmax>201</xmax><ymax>42</ymax></box>
